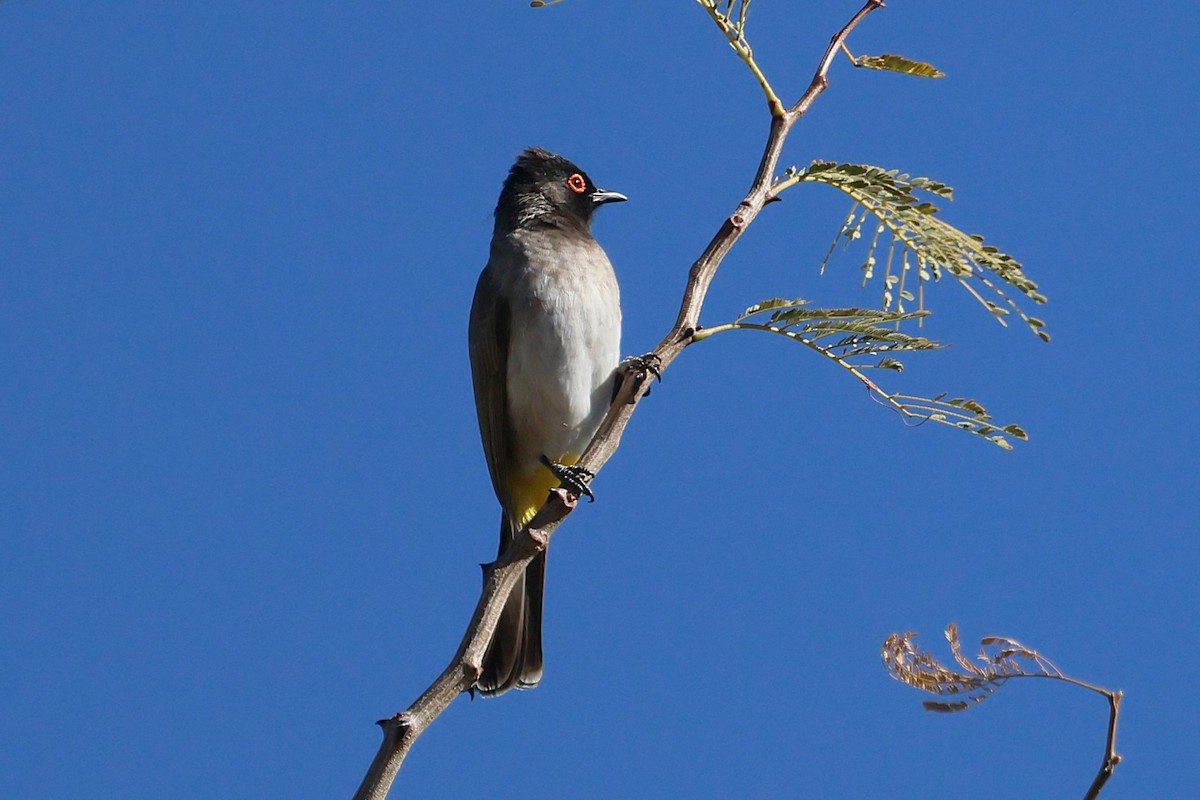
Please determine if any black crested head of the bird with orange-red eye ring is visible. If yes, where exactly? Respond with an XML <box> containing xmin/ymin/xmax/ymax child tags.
<box><xmin>496</xmin><ymin>148</ymin><xmax>629</xmax><ymax>230</ymax></box>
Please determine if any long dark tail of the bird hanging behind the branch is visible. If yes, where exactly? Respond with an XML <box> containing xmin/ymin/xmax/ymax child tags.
<box><xmin>476</xmin><ymin>513</ymin><xmax>546</xmax><ymax>694</ymax></box>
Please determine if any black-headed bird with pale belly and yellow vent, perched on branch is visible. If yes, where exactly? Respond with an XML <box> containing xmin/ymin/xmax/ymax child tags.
<box><xmin>468</xmin><ymin>148</ymin><xmax>629</xmax><ymax>696</ymax></box>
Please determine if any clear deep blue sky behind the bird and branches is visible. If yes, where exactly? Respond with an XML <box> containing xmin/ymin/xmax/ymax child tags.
<box><xmin>0</xmin><ymin>0</ymin><xmax>1200</xmax><ymax>799</ymax></box>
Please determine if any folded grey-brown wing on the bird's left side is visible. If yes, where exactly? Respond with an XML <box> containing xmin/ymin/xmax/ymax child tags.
<box><xmin>468</xmin><ymin>266</ymin><xmax>512</xmax><ymax>509</ymax></box>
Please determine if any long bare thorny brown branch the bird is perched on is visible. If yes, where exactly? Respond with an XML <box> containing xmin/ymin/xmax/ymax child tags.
<box><xmin>354</xmin><ymin>0</ymin><xmax>884</xmax><ymax>800</ymax></box>
